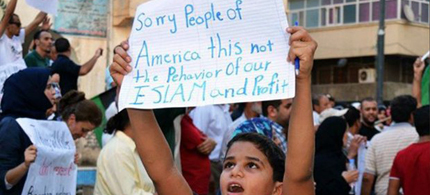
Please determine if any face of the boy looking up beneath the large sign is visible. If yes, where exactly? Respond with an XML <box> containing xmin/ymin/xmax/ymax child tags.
<box><xmin>221</xmin><ymin>141</ymin><xmax>282</xmax><ymax>195</ymax></box>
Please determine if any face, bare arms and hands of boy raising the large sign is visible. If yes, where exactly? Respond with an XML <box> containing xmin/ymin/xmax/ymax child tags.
<box><xmin>110</xmin><ymin>27</ymin><xmax>317</xmax><ymax>195</ymax></box>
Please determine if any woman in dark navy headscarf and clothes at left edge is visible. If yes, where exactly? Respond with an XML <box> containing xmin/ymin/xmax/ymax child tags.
<box><xmin>0</xmin><ymin>68</ymin><xmax>56</xmax><ymax>195</ymax></box>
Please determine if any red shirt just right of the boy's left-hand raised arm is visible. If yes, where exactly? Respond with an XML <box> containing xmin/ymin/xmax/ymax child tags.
<box><xmin>180</xmin><ymin>114</ymin><xmax>211</xmax><ymax>195</ymax></box>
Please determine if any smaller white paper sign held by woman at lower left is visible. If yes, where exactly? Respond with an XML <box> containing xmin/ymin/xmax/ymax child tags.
<box><xmin>17</xmin><ymin>118</ymin><xmax>77</xmax><ymax>195</ymax></box>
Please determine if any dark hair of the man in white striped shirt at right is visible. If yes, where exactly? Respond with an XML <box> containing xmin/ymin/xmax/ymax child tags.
<box><xmin>391</xmin><ymin>95</ymin><xmax>417</xmax><ymax>123</ymax></box>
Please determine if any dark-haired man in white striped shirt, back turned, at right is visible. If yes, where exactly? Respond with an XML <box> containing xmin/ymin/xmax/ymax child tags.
<box><xmin>361</xmin><ymin>95</ymin><xmax>418</xmax><ymax>195</ymax></box>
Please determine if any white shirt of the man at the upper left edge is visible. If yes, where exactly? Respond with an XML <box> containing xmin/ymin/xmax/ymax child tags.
<box><xmin>0</xmin><ymin>29</ymin><xmax>25</xmax><ymax>66</ymax></box>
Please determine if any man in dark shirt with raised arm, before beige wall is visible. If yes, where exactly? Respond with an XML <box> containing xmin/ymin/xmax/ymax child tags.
<box><xmin>52</xmin><ymin>38</ymin><xmax>103</xmax><ymax>95</ymax></box>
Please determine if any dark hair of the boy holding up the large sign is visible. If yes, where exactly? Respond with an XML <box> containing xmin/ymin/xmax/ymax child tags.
<box><xmin>226</xmin><ymin>133</ymin><xmax>285</xmax><ymax>182</ymax></box>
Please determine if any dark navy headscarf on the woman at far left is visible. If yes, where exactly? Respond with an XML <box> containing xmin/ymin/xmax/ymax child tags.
<box><xmin>1</xmin><ymin>68</ymin><xmax>52</xmax><ymax>119</ymax></box>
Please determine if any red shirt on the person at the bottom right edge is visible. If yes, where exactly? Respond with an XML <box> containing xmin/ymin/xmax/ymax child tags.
<box><xmin>390</xmin><ymin>142</ymin><xmax>430</xmax><ymax>195</ymax></box>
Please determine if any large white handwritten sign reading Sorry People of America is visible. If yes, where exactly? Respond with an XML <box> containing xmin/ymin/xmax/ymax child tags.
<box><xmin>119</xmin><ymin>0</ymin><xmax>295</xmax><ymax>109</ymax></box>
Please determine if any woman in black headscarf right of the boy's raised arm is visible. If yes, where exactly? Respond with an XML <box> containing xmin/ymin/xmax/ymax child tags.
<box><xmin>314</xmin><ymin>117</ymin><xmax>358</xmax><ymax>195</ymax></box>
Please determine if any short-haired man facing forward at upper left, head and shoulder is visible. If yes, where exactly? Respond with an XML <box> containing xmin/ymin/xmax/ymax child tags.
<box><xmin>24</xmin><ymin>30</ymin><xmax>52</xmax><ymax>68</ymax></box>
